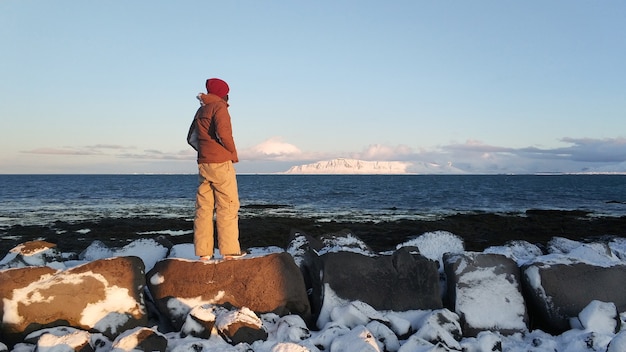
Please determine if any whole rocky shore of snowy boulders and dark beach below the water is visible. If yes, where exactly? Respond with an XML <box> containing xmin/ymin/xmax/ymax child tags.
<box><xmin>0</xmin><ymin>210</ymin><xmax>626</xmax><ymax>352</ymax></box>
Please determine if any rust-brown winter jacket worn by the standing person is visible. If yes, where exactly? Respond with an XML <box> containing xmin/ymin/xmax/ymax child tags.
<box><xmin>194</xmin><ymin>94</ymin><xmax>239</xmax><ymax>164</ymax></box>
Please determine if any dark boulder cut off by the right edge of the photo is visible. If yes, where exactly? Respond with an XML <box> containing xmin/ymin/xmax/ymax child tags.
<box><xmin>522</xmin><ymin>262</ymin><xmax>626</xmax><ymax>333</ymax></box>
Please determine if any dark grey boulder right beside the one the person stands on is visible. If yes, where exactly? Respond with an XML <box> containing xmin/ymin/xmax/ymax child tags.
<box><xmin>313</xmin><ymin>248</ymin><xmax>443</xmax><ymax>327</ymax></box>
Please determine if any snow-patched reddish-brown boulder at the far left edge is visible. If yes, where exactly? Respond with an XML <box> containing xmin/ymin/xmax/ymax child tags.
<box><xmin>0</xmin><ymin>257</ymin><xmax>147</xmax><ymax>344</ymax></box>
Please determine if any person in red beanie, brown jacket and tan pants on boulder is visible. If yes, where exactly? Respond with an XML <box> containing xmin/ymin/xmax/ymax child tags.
<box><xmin>187</xmin><ymin>78</ymin><xmax>246</xmax><ymax>260</ymax></box>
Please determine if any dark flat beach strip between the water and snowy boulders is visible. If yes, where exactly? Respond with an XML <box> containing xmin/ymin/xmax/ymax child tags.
<box><xmin>0</xmin><ymin>210</ymin><xmax>626</xmax><ymax>256</ymax></box>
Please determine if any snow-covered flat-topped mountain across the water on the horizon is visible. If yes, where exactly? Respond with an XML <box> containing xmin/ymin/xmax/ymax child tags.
<box><xmin>284</xmin><ymin>158</ymin><xmax>464</xmax><ymax>175</ymax></box>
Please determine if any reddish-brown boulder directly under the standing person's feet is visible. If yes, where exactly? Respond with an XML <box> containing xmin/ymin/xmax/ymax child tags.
<box><xmin>147</xmin><ymin>252</ymin><xmax>311</xmax><ymax>329</ymax></box>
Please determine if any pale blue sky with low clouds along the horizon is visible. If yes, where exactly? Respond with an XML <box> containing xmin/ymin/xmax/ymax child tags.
<box><xmin>0</xmin><ymin>0</ymin><xmax>626</xmax><ymax>173</ymax></box>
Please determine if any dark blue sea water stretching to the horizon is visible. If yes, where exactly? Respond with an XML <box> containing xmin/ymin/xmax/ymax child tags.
<box><xmin>0</xmin><ymin>175</ymin><xmax>626</xmax><ymax>228</ymax></box>
